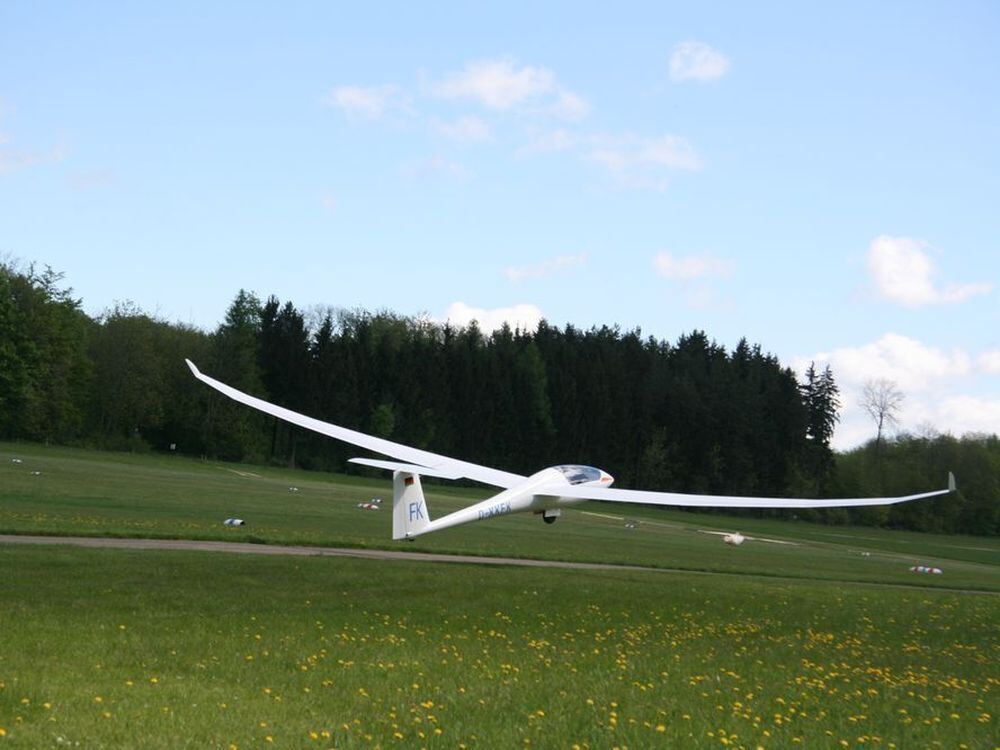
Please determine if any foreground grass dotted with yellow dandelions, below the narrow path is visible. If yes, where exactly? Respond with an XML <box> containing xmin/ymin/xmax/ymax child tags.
<box><xmin>0</xmin><ymin>547</ymin><xmax>1000</xmax><ymax>748</ymax></box>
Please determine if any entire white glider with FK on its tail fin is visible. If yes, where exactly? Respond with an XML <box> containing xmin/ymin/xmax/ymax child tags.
<box><xmin>185</xmin><ymin>359</ymin><xmax>955</xmax><ymax>539</ymax></box>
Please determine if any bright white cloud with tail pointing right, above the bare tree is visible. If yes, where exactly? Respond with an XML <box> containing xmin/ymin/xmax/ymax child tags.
<box><xmin>868</xmin><ymin>234</ymin><xmax>993</xmax><ymax>307</ymax></box>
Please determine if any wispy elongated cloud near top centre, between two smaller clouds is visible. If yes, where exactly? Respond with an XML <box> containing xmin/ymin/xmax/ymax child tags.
<box><xmin>430</xmin><ymin>57</ymin><xmax>590</xmax><ymax>120</ymax></box>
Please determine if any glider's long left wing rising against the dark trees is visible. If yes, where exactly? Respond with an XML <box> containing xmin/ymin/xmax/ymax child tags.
<box><xmin>184</xmin><ymin>359</ymin><xmax>525</xmax><ymax>488</ymax></box>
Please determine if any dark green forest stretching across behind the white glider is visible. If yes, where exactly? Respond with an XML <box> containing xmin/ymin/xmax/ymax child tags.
<box><xmin>0</xmin><ymin>262</ymin><xmax>1000</xmax><ymax>535</ymax></box>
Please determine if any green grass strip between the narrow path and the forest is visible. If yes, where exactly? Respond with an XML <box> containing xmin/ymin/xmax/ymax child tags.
<box><xmin>0</xmin><ymin>443</ymin><xmax>1000</xmax><ymax>591</ymax></box>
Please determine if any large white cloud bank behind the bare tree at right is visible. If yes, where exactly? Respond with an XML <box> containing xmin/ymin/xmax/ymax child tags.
<box><xmin>792</xmin><ymin>333</ymin><xmax>1000</xmax><ymax>449</ymax></box>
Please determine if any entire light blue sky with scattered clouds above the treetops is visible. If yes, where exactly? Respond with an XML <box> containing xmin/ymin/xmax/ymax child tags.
<box><xmin>0</xmin><ymin>2</ymin><xmax>1000</xmax><ymax>447</ymax></box>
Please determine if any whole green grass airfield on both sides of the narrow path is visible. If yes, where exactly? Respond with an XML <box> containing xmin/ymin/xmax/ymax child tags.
<box><xmin>0</xmin><ymin>444</ymin><xmax>1000</xmax><ymax>749</ymax></box>
